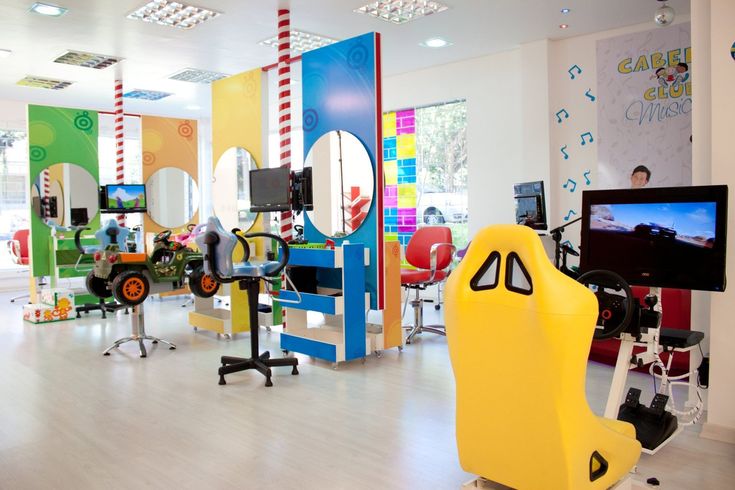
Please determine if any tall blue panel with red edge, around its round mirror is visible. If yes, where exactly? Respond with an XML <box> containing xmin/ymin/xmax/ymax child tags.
<box><xmin>302</xmin><ymin>33</ymin><xmax>385</xmax><ymax>309</ymax></box>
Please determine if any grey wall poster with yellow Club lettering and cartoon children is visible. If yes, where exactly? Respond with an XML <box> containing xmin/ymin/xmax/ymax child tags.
<box><xmin>597</xmin><ymin>23</ymin><xmax>692</xmax><ymax>188</ymax></box>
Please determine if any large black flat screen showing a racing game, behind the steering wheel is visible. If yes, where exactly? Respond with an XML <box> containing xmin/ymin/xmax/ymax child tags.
<box><xmin>580</xmin><ymin>185</ymin><xmax>727</xmax><ymax>291</ymax></box>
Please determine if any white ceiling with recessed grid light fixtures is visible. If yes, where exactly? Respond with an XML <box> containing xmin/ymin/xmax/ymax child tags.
<box><xmin>0</xmin><ymin>0</ymin><xmax>689</xmax><ymax>118</ymax></box>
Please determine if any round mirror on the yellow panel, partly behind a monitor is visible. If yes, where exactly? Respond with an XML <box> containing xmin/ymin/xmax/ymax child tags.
<box><xmin>212</xmin><ymin>146</ymin><xmax>258</xmax><ymax>231</ymax></box>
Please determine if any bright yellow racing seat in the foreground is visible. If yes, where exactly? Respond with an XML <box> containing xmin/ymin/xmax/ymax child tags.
<box><xmin>445</xmin><ymin>225</ymin><xmax>641</xmax><ymax>490</ymax></box>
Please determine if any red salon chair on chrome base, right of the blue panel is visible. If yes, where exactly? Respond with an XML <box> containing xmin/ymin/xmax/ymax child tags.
<box><xmin>401</xmin><ymin>226</ymin><xmax>455</xmax><ymax>344</ymax></box>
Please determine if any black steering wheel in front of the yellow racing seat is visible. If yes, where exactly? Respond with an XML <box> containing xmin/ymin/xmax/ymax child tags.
<box><xmin>577</xmin><ymin>270</ymin><xmax>634</xmax><ymax>340</ymax></box>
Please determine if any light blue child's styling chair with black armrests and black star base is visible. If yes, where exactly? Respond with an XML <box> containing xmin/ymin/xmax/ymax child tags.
<box><xmin>196</xmin><ymin>216</ymin><xmax>299</xmax><ymax>386</ymax></box>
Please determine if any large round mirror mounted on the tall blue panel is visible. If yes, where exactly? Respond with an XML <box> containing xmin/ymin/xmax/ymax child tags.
<box><xmin>304</xmin><ymin>131</ymin><xmax>375</xmax><ymax>237</ymax></box>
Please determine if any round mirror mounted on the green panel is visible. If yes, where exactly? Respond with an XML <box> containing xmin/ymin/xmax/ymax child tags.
<box><xmin>31</xmin><ymin>163</ymin><xmax>99</xmax><ymax>226</ymax></box>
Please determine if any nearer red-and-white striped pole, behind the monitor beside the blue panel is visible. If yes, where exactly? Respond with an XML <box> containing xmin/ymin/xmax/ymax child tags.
<box><xmin>278</xmin><ymin>9</ymin><xmax>293</xmax><ymax>242</ymax></box>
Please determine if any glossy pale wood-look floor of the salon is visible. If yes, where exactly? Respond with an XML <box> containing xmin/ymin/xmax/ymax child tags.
<box><xmin>0</xmin><ymin>294</ymin><xmax>735</xmax><ymax>490</ymax></box>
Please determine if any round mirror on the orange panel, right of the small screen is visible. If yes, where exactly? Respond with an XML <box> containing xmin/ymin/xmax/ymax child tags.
<box><xmin>145</xmin><ymin>167</ymin><xmax>199</xmax><ymax>229</ymax></box>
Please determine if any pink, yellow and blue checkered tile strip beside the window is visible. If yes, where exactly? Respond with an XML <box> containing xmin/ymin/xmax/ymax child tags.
<box><xmin>383</xmin><ymin>109</ymin><xmax>417</xmax><ymax>246</ymax></box>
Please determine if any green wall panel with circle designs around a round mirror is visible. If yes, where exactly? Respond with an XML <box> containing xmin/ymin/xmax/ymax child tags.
<box><xmin>28</xmin><ymin>105</ymin><xmax>100</xmax><ymax>277</ymax></box>
